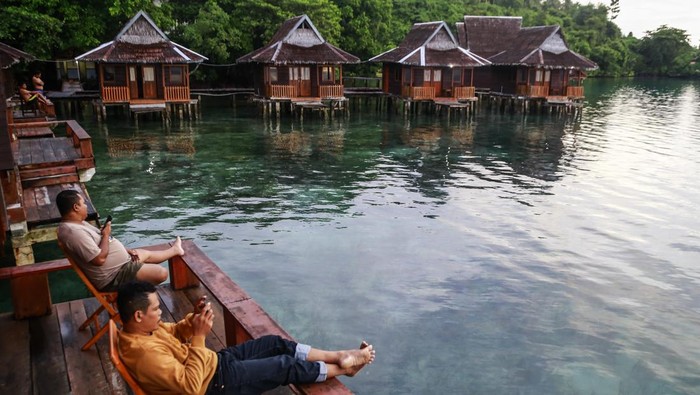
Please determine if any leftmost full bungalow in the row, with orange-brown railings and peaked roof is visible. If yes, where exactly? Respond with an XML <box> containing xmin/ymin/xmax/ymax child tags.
<box><xmin>75</xmin><ymin>11</ymin><xmax>207</xmax><ymax>119</ymax></box>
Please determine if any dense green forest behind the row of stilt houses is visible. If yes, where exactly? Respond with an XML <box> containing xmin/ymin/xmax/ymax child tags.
<box><xmin>0</xmin><ymin>0</ymin><xmax>700</xmax><ymax>81</ymax></box>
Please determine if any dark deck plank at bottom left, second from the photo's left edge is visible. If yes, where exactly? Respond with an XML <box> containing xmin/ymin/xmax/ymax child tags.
<box><xmin>29</xmin><ymin>307</ymin><xmax>70</xmax><ymax>394</ymax></box>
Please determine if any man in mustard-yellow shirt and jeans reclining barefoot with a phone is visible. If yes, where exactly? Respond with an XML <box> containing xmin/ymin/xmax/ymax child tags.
<box><xmin>117</xmin><ymin>281</ymin><xmax>375</xmax><ymax>394</ymax></box>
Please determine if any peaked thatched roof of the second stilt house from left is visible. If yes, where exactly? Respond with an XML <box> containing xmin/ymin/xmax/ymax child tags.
<box><xmin>236</xmin><ymin>15</ymin><xmax>360</xmax><ymax>64</ymax></box>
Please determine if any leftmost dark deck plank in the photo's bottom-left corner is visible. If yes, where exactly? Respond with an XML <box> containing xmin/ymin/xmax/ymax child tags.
<box><xmin>0</xmin><ymin>314</ymin><xmax>32</xmax><ymax>395</ymax></box>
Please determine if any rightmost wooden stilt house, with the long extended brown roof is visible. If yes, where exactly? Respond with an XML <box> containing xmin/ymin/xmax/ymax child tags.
<box><xmin>456</xmin><ymin>15</ymin><xmax>598</xmax><ymax>99</ymax></box>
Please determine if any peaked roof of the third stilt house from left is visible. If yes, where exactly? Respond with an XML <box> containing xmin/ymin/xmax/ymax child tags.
<box><xmin>369</xmin><ymin>22</ymin><xmax>490</xmax><ymax>67</ymax></box>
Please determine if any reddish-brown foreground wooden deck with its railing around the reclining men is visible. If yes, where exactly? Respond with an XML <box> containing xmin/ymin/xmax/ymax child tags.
<box><xmin>0</xmin><ymin>240</ymin><xmax>350</xmax><ymax>395</ymax></box>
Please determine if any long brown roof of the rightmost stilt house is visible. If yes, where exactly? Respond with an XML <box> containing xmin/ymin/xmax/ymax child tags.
<box><xmin>457</xmin><ymin>15</ymin><xmax>598</xmax><ymax>69</ymax></box>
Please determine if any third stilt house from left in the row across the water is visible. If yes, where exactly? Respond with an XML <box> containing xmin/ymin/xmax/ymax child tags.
<box><xmin>369</xmin><ymin>22</ymin><xmax>490</xmax><ymax>100</ymax></box>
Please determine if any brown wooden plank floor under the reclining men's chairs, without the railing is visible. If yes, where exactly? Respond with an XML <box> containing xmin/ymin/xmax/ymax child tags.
<box><xmin>0</xmin><ymin>285</ymin><xmax>292</xmax><ymax>395</ymax></box>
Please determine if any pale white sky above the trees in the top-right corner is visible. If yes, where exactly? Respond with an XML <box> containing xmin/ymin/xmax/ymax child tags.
<box><xmin>575</xmin><ymin>0</ymin><xmax>700</xmax><ymax>47</ymax></box>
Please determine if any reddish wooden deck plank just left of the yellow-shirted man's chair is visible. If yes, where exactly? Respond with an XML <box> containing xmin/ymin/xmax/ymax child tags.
<box><xmin>56</xmin><ymin>301</ymin><xmax>109</xmax><ymax>394</ymax></box>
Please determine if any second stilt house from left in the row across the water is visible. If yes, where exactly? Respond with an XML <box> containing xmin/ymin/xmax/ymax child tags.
<box><xmin>236</xmin><ymin>15</ymin><xmax>360</xmax><ymax>100</ymax></box>
